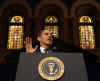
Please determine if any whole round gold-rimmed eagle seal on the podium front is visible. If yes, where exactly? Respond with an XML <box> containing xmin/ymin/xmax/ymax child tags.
<box><xmin>38</xmin><ymin>57</ymin><xmax>64</xmax><ymax>80</ymax></box>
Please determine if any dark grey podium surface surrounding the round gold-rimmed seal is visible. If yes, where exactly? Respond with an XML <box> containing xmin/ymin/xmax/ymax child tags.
<box><xmin>15</xmin><ymin>53</ymin><xmax>88</xmax><ymax>81</ymax></box>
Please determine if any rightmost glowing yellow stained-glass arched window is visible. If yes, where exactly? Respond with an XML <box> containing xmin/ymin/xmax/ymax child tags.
<box><xmin>79</xmin><ymin>16</ymin><xmax>95</xmax><ymax>49</ymax></box>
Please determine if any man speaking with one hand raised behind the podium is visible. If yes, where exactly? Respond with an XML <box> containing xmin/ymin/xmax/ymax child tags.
<box><xmin>24</xmin><ymin>29</ymin><xmax>53</xmax><ymax>54</ymax></box>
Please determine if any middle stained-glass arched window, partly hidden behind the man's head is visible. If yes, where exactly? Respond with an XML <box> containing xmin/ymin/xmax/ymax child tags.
<box><xmin>45</xmin><ymin>16</ymin><xmax>59</xmax><ymax>38</ymax></box>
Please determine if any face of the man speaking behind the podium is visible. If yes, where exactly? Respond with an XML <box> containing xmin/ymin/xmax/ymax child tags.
<box><xmin>38</xmin><ymin>30</ymin><xmax>53</xmax><ymax>45</ymax></box>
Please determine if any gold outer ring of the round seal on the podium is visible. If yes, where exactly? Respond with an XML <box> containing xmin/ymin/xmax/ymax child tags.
<box><xmin>38</xmin><ymin>57</ymin><xmax>64</xmax><ymax>80</ymax></box>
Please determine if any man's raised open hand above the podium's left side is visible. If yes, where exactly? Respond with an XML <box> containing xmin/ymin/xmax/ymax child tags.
<box><xmin>24</xmin><ymin>37</ymin><xmax>38</xmax><ymax>53</ymax></box>
